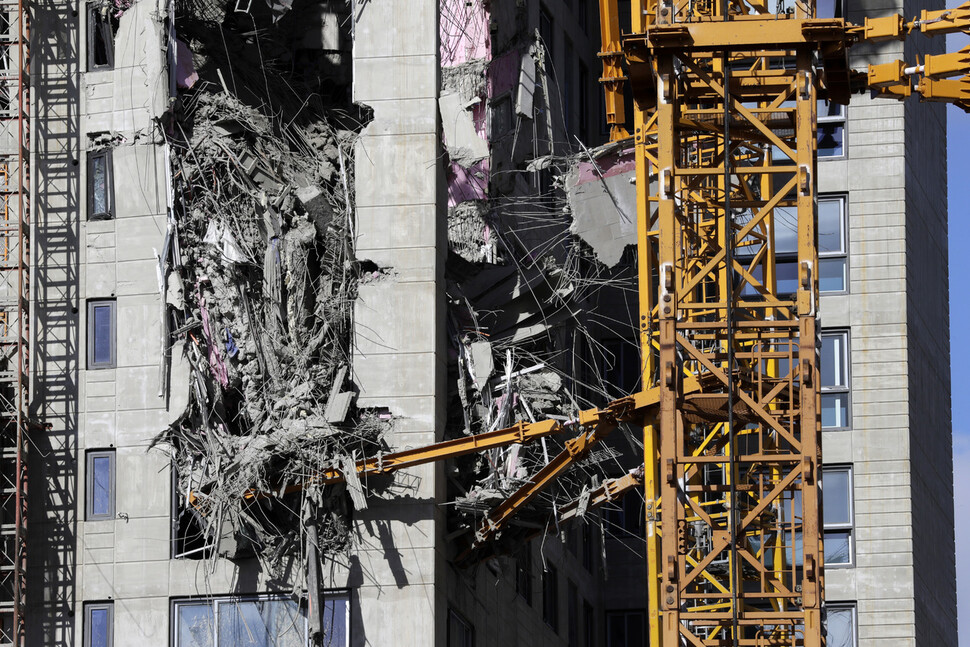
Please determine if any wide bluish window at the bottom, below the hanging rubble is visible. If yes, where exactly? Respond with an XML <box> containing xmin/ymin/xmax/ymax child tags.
<box><xmin>172</xmin><ymin>592</ymin><xmax>350</xmax><ymax>647</ymax></box>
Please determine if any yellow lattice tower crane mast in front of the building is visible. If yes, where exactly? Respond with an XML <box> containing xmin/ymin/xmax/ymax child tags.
<box><xmin>600</xmin><ymin>0</ymin><xmax>970</xmax><ymax>647</ymax></box>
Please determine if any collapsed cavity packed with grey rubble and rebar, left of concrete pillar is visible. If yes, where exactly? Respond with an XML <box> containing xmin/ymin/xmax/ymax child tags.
<box><xmin>158</xmin><ymin>0</ymin><xmax>386</xmax><ymax>568</ymax></box>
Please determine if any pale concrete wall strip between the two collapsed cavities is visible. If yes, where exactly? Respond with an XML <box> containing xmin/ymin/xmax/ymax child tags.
<box><xmin>352</xmin><ymin>0</ymin><xmax>447</xmax><ymax>646</ymax></box>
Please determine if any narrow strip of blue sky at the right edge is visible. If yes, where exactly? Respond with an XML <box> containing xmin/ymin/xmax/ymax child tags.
<box><xmin>947</xmin><ymin>12</ymin><xmax>970</xmax><ymax>647</ymax></box>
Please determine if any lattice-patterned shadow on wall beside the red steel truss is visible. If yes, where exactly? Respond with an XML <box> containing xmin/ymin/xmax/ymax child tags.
<box><xmin>27</xmin><ymin>1</ymin><xmax>80</xmax><ymax>647</ymax></box>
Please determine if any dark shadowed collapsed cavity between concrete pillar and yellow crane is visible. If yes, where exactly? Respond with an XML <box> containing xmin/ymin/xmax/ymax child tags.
<box><xmin>438</xmin><ymin>0</ymin><xmax>635</xmax><ymax>561</ymax></box>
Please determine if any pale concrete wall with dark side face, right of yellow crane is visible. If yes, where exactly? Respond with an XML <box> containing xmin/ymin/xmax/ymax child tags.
<box><xmin>819</xmin><ymin>2</ymin><xmax>956</xmax><ymax>646</ymax></box>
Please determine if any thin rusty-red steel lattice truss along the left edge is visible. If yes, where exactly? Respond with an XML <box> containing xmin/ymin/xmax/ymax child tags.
<box><xmin>0</xmin><ymin>0</ymin><xmax>30</xmax><ymax>645</ymax></box>
